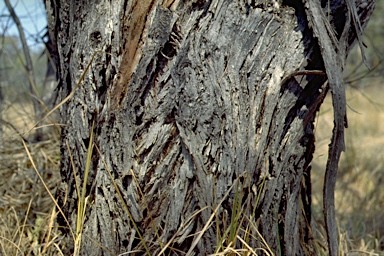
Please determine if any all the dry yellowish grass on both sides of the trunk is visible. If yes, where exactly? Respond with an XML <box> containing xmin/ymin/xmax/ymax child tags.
<box><xmin>0</xmin><ymin>83</ymin><xmax>384</xmax><ymax>255</ymax></box>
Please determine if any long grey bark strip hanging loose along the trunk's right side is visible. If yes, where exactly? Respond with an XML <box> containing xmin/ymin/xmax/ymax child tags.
<box><xmin>303</xmin><ymin>0</ymin><xmax>374</xmax><ymax>256</ymax></box>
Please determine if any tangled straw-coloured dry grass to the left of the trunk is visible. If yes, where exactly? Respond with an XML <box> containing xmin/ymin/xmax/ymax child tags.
<box><xmin>0</xmin><ymin>104</ymin><xmax>61</xmax><ymax>255</ymax></box>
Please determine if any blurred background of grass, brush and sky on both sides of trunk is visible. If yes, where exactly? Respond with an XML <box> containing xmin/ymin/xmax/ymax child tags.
<box><xmin>0</xmin><ymin>0</ymin><xmax>384</xmax><ymax>255</ymax></box>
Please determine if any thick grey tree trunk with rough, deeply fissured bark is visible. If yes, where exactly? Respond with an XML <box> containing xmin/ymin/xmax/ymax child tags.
<box><xmin>47</xmin><ymin>0</ymin><xmax>374</xmax><ymax>255</ymax></box>
